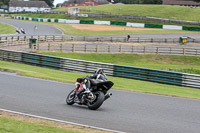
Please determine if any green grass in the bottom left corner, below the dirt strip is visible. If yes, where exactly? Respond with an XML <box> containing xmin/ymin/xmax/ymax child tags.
<box><xmin>0</xmin><ymin>117</ymin><xmax>78</xmax><ymax>133</ymax></box>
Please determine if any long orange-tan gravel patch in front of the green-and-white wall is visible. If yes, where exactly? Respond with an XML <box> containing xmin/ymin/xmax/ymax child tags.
<box><xmin>70</xmin><ymin>24</ymin><xmax>162</xmax><ymax>31</ymax></box>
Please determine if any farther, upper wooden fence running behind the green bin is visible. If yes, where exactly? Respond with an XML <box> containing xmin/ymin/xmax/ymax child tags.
<box><xmin>0</xmin><ymin>36</ymin><xmax>197</xmax><ymax>43</ymax></box>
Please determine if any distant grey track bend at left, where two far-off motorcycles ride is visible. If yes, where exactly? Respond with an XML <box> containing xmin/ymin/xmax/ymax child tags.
<box><xmin>0</xmin><ymin>18</ymin><xmax>63</xmax><ymax>36</ymax></box>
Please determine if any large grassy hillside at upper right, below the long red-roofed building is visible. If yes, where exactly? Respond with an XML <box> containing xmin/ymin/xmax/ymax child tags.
<box><xmin>77</xmin><ymin>4</ymin><xmax>200</xmax><ymax>22</ymax></box>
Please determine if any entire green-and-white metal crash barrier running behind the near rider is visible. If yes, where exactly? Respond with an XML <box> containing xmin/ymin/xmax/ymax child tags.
<box><xmin>0</xmin><ymin>50</ymin><xmax>200</xmax><ymax>89</ymax></box>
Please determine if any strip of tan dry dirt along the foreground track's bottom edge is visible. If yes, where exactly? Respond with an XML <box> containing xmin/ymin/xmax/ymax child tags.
<box><xmin>0</xmin><ymin>111</ymin><xmax>111</xmax><ymax>133</ymax></box>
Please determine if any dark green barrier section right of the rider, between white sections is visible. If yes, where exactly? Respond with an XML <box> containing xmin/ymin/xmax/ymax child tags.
<box><xmin>114</xmin><ymin>65</ymin><xmax>183</xmax><ymax>86</ymax></box>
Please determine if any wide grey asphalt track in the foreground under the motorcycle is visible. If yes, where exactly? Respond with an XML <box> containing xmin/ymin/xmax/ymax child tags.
<box><xmin>0</xmin><ymin>72</ymin><xmax>200</xmax><ymax>133</ymax></box>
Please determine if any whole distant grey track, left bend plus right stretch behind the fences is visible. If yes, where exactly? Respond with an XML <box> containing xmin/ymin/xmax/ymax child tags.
<box><xmin>0</xmin><ymin>18</ymin><xmax>200</xmax><ymax>40</ymax></box>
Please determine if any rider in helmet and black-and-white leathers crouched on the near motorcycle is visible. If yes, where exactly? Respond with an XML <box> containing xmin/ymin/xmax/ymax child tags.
<box><xmin>75</xmin><ymin>68</ymin><xmax>107</xmax><ymax>103</ymax></box>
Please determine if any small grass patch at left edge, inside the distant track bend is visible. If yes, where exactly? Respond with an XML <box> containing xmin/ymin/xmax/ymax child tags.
<box><xmin>0</xmin><ymin>23</ymin><xmax>16</xmax><ymax>35</ymax></box>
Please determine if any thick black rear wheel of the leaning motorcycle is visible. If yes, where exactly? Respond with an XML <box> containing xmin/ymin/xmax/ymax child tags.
<box><xmin>87</xmin><ymin>91</ymin><xmax>105</xmax><ymax>110</ymax></box>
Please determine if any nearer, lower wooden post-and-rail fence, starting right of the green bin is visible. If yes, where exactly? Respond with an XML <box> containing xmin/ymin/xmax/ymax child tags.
<box><xmin>36</xmin><ymin>43</ymin><xmax>200</xmax><ymax>55</ymax></box>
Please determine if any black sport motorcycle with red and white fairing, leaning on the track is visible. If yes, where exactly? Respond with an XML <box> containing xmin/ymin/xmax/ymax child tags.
<box><xmin>66</xmin><ymin>78</ymin><xmax>114</xmax><ymax>110</ymax></box>
